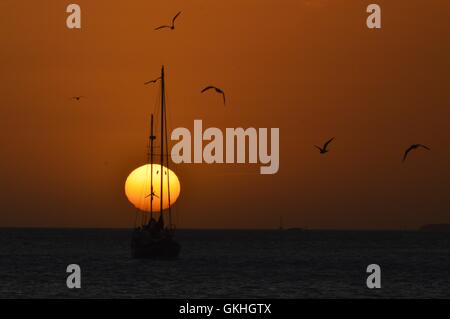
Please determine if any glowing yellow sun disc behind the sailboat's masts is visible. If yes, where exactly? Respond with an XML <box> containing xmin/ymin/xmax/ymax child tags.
<box><xmin>125</xmin><ymin>164</ymin><xmax>181</xmax><ymax>212</ymax></box>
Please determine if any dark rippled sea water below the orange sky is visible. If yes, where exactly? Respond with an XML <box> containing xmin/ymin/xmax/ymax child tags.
<box><xmin>0</xmin><ymin>229</ymin><xmax>450</xmax><ymax>298</ymax></box>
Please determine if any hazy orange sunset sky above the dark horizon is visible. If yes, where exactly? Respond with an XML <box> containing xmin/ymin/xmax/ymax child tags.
<box><xmin>0</xmin><ymin>0</ymin><xmax>450</xmax><ymax>229</ymax></box>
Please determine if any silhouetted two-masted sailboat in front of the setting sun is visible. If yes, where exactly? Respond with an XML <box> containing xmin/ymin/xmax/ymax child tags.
<box><xmin>131</xmin><ymin>66</ymin><xmax>181</xmax><ymax>259</ymax></box>
